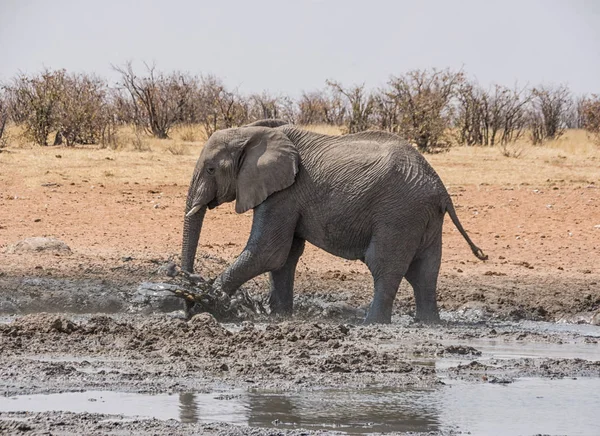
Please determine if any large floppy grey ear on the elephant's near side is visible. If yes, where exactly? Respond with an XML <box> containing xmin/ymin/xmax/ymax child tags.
<box><xmin>235</xmin><ymin>128</ymin><xmax>300</xmax><ymax>213</ymax></box>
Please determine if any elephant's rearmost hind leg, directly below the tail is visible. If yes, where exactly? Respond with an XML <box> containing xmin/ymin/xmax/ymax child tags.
<box><xmin>405</xmin><ymin>240</ymin><xmax>442</xmax><ymax>322</ymax></box>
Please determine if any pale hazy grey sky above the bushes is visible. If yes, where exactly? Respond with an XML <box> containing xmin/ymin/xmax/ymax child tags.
<box><xmin>0</xmin><ymin>0</ymin><xmax>600</xmax><ymax>96</ymax></box>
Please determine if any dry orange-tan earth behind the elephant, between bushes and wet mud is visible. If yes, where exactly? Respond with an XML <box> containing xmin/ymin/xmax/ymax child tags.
<box><xmin>0</xmin><ymin>128</ymin><xmax>600</xmax><ymax>320</ymax></box>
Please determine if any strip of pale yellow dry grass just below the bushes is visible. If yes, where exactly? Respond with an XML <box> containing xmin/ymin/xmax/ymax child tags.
<box><xmin>0</xmin><ymin>126</ymin><xmax>600</xmax><ymax>190</ymax></box>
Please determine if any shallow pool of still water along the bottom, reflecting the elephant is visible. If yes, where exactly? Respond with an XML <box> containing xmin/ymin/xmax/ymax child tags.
<box><xmin>0</xmin><ymin>378</ymin><xmax>600</xmax><ymax>436</ymax></box>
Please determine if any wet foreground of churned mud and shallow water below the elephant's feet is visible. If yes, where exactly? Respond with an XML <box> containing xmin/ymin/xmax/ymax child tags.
<box><xmin>0</xmin><ymin>313</ymin><xmax>600</xmax><ymax>435</ymax></box>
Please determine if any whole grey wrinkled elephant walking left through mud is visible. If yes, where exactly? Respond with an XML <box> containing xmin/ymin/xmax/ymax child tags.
<box><xmin>182</xmin><ymin>120</ymin><xmax>486</xmax><ymax>323</ymax></box>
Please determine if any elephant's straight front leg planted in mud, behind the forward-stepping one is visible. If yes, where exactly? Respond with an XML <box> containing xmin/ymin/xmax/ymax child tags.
<box><xmin>269</xmin><ymin>238</ymin><xmax>304</xmax><ymax>315</ymax></box>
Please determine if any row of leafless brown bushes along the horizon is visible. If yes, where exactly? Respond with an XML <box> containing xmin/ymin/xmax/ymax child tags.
<box><xmin>0</xmin><ymin>63</ymin><xmax>600</xmax><ymax>157</ymax></box>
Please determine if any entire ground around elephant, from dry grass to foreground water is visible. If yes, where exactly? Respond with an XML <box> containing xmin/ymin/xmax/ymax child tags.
<box><xmin>0</xmin><ymin>126</ymin><xmax>600</xmax><ymax>435</ymax></box>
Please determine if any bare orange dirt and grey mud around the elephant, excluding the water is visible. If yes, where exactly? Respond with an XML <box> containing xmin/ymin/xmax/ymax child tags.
<box><xmin>0</xmin><ymin>138</ymin><xmax>600</xmax><ymax>434</ymax></box>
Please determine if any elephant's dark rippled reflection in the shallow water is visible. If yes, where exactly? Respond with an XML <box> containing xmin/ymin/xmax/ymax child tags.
<box><xmin>179</xmin><ymin>389</ymin><xmax>440</xmax><ymax>433</ymax></box>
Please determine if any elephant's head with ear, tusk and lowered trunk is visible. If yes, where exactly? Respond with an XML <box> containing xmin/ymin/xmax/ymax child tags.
<box><xmin>181</xmin><ymin>120</ymin><xmax>299</xmax><ymax>273</ymax></box>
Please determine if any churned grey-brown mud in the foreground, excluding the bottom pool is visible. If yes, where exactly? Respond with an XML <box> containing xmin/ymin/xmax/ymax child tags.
<box><xmin>0</xmin><ymin>314</ymin><xmax>600</xmax><ymax>434</ymax></box>
